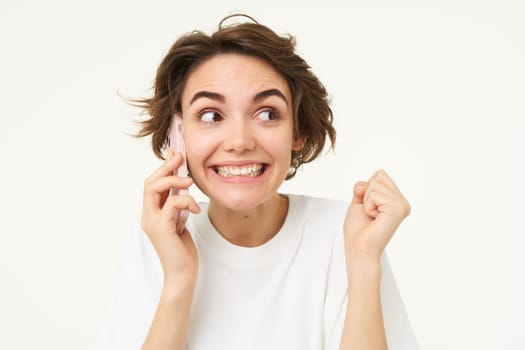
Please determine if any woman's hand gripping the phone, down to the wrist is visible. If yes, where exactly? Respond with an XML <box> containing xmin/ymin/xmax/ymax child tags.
<box><xmin>141</xmin><ymin>150</ymin><xmax>200</xmax><ymax>284</ymax></box>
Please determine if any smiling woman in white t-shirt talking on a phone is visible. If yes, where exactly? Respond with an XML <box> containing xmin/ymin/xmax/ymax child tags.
<box><xmin>97</xmin><ymin>14</ymin><xmax>417</xmax><ymax>350</ymax></box>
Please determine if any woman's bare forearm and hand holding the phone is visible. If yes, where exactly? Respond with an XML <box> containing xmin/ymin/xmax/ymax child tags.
<box><xmin>141</xmin><ymin>150</ymin><xmax>200</xmax><ymax>350</ymax></box>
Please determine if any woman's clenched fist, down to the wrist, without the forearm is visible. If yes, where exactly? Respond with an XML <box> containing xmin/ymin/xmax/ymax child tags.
<box><xmin>344</xmin><ymin>170</ymin><xmax>410</xmax><ymax>262</ymax></box>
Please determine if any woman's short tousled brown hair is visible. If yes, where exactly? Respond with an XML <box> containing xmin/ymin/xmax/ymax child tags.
<box><xmin>131</xmin><ymin>15</ymin><xmax>336</xmax><ymax>180</ymax></box>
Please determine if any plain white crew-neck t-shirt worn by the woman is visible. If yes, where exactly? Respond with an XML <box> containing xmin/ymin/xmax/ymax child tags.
<box><xmin>97</xmin><ymin>195</ymin><xmax>418</xmax><ymax>350</ymax></box>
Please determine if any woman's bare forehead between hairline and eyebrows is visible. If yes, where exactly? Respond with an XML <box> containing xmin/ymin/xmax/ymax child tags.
<box><xmin>182</xmin><ymin>54</ymin><xmax>291</xmax><ymax>105</ymax></box>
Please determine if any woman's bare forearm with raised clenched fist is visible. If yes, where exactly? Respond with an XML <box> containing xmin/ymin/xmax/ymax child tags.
<box><xmin>340</xmin><ymin>170</ymin><xmax>410</xmax><ymax>350</ymax></box>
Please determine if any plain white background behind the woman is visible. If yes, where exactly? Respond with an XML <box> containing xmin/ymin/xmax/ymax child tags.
<box><xmin>0</xmin><ymin>0</ymin><xmax>525</xmax><ymax>349</ymax></box>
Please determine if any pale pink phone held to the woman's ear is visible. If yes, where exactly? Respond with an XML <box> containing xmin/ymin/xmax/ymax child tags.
<box><xmin>168</xmin><ymin>114</ymin><xmax>188</xmax><ymax>235</ymax></box>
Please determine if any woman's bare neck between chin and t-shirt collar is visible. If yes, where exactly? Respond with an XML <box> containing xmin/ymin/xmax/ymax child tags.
<box><xmin>208</xmin><ymin>193</ymin><xmax>288</xmax><ymax>247</ymax></box>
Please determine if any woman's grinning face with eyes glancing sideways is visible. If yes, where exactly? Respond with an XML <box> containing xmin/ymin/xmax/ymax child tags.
<box><xmin>182</xmin><ymin>54</ymin><xmax>302</xmax><ymax>210</ymax></box>
